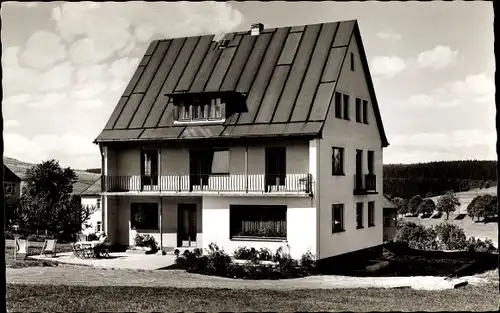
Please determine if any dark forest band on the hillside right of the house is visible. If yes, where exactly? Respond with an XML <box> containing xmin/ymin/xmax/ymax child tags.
<box><xmin>384</xmin><ymin>160</ymin><xmax>497</xmax><ymax>198</ymax></box>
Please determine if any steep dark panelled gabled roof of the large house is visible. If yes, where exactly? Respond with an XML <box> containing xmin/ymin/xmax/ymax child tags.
<box><xmin>95</xmin><ymin>20</ymin><xmax>387</xmax><ymax>146</ymax></box>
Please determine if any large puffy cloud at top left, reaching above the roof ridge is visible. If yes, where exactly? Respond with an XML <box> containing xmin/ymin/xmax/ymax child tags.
<box><xmin>52</xmin><ymin>2</ymin><xmax>243</xmax><ymax>64</ymax></box>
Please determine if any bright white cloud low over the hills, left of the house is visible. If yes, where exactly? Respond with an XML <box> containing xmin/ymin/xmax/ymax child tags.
<box><xmin>4</xmin><ymin>132</ymin><xmax>99</xmax><ymax>168</ymax></box>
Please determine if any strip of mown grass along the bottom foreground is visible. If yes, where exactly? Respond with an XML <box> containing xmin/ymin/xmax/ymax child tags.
<box><xmin>6</xmin><ymin>284</ymin><xmax>498</xmax><ymax>312</ymax></box>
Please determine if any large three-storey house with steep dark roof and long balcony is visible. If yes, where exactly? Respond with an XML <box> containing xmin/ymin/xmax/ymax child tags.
<box><xmin>95</xmin><ymin>21</ymin><xmax>388</xmax><ymax>259</ymax></box>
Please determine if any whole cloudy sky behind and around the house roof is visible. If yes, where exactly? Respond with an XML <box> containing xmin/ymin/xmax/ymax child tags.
<box><xmin>1</xmin><ymin>1</ymin><xmax>497</xmax><ymax>169</ymax></box>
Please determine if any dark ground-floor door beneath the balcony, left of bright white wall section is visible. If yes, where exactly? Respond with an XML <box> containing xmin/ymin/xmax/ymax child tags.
<box><xmin>177</xmin><ymin>203</ymin><xmax>196</xmax><ymax>247</ymax></box>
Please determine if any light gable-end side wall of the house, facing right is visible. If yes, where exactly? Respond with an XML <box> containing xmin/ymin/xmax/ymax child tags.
<box><xmin>317</xmin><ymin>33</ymin><xmax>383</xmax><ymax>258</ymax></box>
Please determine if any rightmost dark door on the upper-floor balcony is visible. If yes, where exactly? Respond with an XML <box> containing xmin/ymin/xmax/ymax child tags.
<box><xmin>265</xmin><ymin>147</ymin><xmax>286</xmax><ymax>191</ymax></box>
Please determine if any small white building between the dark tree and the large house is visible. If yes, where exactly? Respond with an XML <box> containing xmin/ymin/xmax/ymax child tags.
<box><xmin>80</xmin><ymin>179</ymin><xmax>102</xmax><ymax>235</ymax></box>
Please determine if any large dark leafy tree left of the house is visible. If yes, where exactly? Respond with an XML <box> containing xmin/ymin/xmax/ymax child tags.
<box><xmin>16</xmin><ymin>160</ymin><xmax>88</xmax><ymax>237</ymax></box>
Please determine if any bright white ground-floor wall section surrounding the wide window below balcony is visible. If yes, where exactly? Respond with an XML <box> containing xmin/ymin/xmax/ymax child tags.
<box><xmin>202</xmin><ymin>196</ymin><xmax>316</xmax><ymax>258</ymax></box>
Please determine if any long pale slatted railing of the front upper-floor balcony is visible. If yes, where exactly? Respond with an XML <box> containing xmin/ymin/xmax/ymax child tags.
<box><xmin>102</xmin><ymin>174</ymin><xmax>313</xmax><ymax>194</ymax></box>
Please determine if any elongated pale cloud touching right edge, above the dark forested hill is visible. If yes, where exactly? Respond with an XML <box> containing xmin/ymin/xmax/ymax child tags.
<box><xmin>400</xmin><ymin>73</ymin><xmax>495</xmax><ymax>109</ymax></box>
